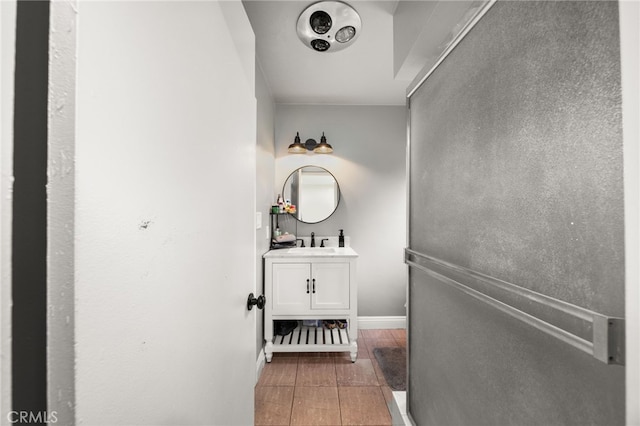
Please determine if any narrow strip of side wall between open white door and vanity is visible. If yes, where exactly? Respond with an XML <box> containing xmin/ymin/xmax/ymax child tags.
<box><xmin>256</xmin><ymin>61</ymin><xmax>275</xmax><ymax>355</ymax></box>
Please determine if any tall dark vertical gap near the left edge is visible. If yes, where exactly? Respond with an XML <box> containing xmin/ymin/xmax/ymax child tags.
<box><xmin>11</xmin><ymin>1</ymin><xmax>49</xmax><ymax>413</ymax></box>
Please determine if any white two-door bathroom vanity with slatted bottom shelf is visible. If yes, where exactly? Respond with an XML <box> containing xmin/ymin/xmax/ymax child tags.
<box><xmin>263</xmin><ymin>247</ymin><xmax>358</xmax><ymax>362</ymax></box>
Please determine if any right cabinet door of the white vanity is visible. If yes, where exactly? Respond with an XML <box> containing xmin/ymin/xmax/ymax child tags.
<box><xmin>311</xmin><ymin>263</ymin><xmax>349</xmax><ymax>309</ymax></box>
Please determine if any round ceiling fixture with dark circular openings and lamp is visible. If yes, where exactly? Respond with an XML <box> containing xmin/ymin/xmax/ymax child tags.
<box><xmin>297</xmin><ymin>1</ymin><xmax>362</xmax><ymax>52</ymax></box>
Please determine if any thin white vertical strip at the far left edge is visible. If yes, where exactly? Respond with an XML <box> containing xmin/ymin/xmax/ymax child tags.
<box><xmin>0</xmin><ymin>0</ymin><xmax>16</xmax><ymax>424</ymax></box>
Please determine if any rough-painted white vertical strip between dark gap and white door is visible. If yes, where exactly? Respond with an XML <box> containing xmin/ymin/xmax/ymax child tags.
<box><xmin>46</xmin><ymin>0</ymin><xmax>82</xmax><ymax>424</ymax></box>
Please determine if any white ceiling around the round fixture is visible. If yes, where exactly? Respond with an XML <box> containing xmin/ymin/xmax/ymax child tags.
<box><xmin>243</xmin><ymin>0</ymin><xmax>412</xmax><ymax>105</ymax></box>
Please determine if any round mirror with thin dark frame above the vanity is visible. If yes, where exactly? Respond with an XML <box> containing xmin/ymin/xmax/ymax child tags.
<box><xmin>282</xmin><ymin>166</ymin><xmax>340</xmax><ymax>223</ymax></box>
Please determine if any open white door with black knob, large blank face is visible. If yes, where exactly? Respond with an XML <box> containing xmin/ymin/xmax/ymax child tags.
<box><xmin>75</xmin><ymin>1</ymin><xmax>256</xmax><ymax>425</ymax></box>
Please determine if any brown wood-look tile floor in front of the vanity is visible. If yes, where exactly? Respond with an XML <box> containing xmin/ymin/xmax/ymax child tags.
<box><xmin>255</xmin><ymin>329</ymin><xmax>407</xmax><ymax>426</ymax></box>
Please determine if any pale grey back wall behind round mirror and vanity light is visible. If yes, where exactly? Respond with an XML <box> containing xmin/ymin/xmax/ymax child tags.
<box><xmin>276</xmin><ymin>104</ymin><xmax>407</xmax><ymax>316</ymax></box>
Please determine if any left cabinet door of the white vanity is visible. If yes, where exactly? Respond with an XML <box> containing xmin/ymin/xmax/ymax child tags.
<box><xmin>271</xmin><ymin>263</ymin><xmax>311</xmax><ymax>314</ymax></box>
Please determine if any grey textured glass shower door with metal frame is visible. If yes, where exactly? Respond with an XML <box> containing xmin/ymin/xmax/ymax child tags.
<box><xmin>408</xmin><ymin>1</ymin><xmax>625</xmax><ymax>425</ymax></box>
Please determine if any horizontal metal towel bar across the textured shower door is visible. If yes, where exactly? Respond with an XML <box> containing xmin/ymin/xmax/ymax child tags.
<box><xmin>405</xmin><ymin>248</ymin><xmax>625</xmax><ymax>365</ymax></box>
